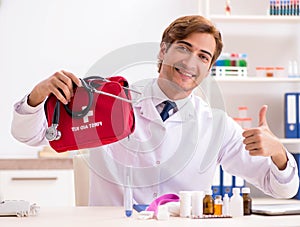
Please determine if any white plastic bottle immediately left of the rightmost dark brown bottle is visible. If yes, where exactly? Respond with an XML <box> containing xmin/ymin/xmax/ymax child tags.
<box><xmin>229</xmin><ymin>188</ymin><xmax>244</xmax><ymax>217</ymax></box>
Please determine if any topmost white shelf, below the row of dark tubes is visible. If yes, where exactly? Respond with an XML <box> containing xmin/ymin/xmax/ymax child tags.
<box><xmin>210</xmin><ymin>15</ymin><xmax>300</xmax><ymax>23</ymax></box>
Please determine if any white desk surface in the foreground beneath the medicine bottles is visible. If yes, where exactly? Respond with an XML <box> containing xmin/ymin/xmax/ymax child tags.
<box><xmin>0</xmin><ymin>201</ymin><xmax>300</xmax><ymax>227</ymax></box>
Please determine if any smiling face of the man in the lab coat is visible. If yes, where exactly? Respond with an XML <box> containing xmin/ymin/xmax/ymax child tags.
<box><xmin>158</xmin><ymin>32</ymin><xmax>216</xmax><ymax>100</ymax></box>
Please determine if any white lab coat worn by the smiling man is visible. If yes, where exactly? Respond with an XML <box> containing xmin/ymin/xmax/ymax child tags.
<box><xmin>12</xmin><ymin>80</ymin><xmax>299</xmax><ymax>205</ymax></box>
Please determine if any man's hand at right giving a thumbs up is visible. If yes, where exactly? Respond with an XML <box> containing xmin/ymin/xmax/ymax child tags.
<box><xmin>243</xmin><ymin>105</ymin><xmax>288</xmax><ymax>170</ymax></box>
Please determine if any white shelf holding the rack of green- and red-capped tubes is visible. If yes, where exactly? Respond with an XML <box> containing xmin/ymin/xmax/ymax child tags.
<box><xmin>212</xmin><ymin>76</ymin><xmax>300</xmax><ymax>83</ymax></box>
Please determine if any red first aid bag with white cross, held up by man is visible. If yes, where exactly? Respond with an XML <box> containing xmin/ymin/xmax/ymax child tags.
<box><xmin>45</xmin><ymin>76</ymin><xmax>135</xmax><ymax>152</ymax></box>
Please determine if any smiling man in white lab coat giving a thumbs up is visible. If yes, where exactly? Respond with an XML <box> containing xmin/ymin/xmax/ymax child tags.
<box><xmin>12</xmin><ymin>16</ymin><xmax>299</xmax><ymax>205</ymax></box>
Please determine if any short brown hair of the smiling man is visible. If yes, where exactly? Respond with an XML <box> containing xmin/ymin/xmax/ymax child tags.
<box><xmin>158</xmin><ymin>15</ymin><xmax>223</xmax><ymax>72</ymax></box>
